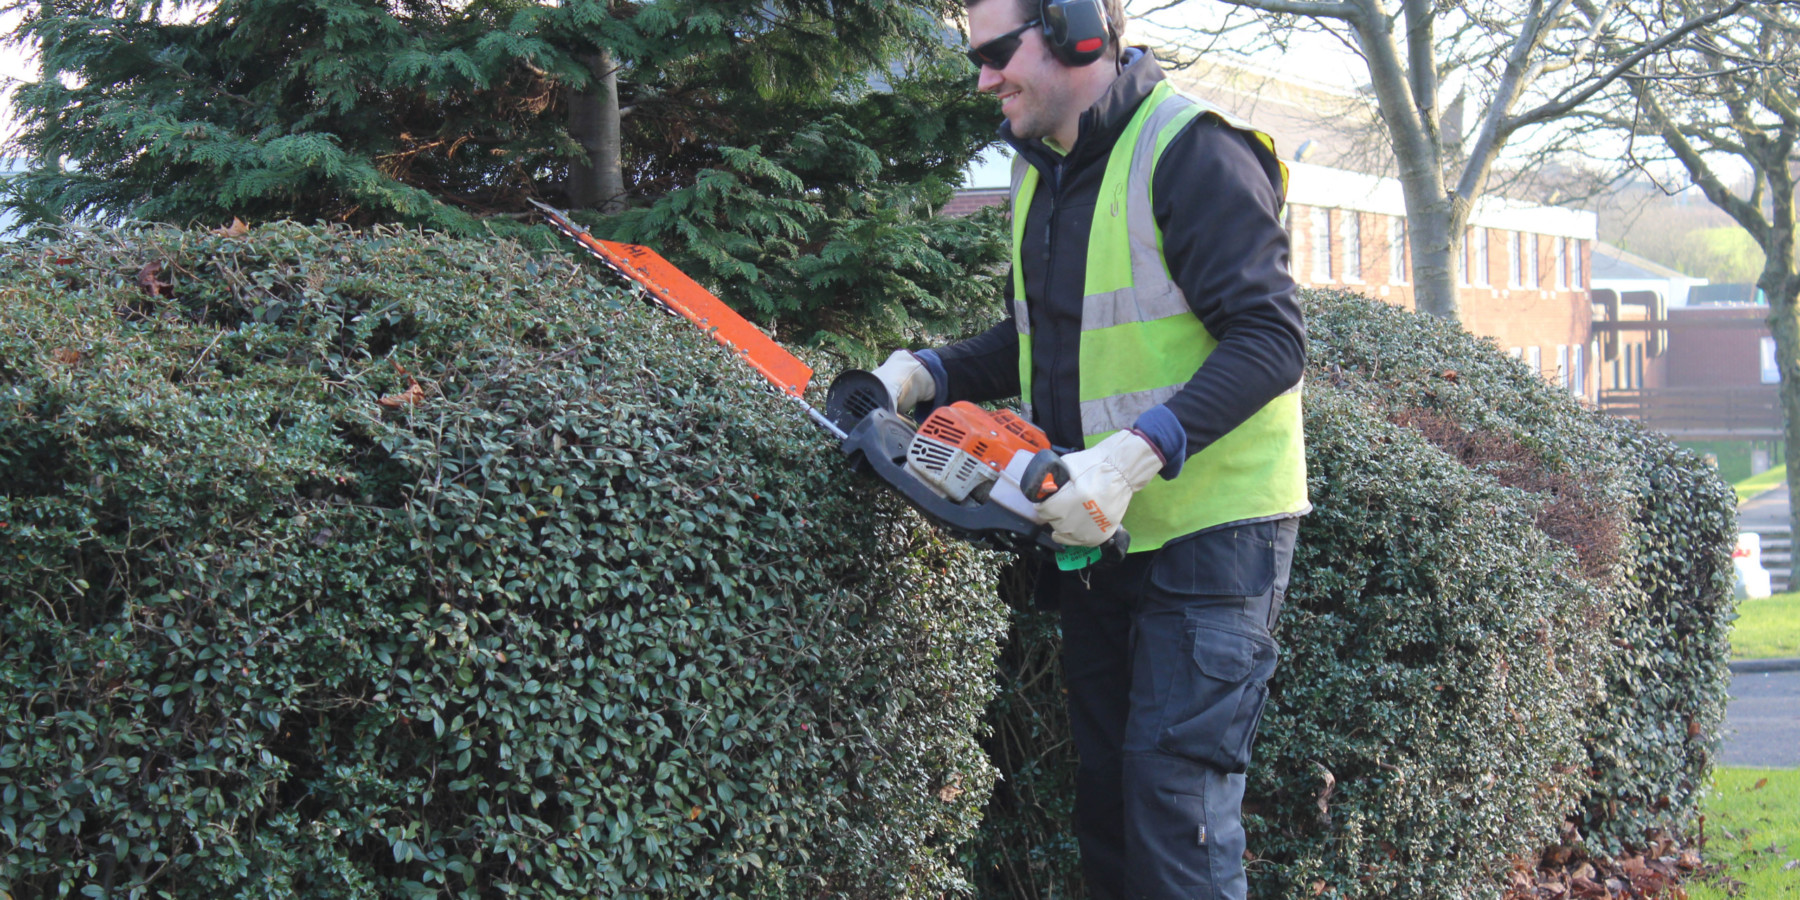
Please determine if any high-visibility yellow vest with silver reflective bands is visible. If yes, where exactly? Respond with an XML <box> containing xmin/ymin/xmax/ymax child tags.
<box><xmin>1012</xmin><ymin>81</ymin><xmax>1310</xmax><ymax>553</ymax></box>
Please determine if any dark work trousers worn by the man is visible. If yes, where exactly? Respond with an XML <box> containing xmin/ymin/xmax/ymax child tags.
<box><xmin>1039</xmin><ymin>518</ymin><xmax>1300</xmax><ymax>900</ymax></box>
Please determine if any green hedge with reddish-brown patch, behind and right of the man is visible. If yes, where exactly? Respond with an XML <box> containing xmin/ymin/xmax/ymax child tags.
<box><xmin>967</xmin><ymin>292</ymin><xmax>1735</xmax><ymax>898</ymax></box>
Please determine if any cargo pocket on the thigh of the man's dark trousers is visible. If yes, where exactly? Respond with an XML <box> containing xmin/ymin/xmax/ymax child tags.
<box><xmin>1156</xmin><ymin>619</ymin><xmax>1276</xmax><ymax>772</ymax></box>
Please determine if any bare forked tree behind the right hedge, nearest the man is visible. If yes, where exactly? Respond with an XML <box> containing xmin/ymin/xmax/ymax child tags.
<box><xmin>1144</xmin><ymin>0</ymin><xmax>1750</xmax><ymax>320</ymax></box>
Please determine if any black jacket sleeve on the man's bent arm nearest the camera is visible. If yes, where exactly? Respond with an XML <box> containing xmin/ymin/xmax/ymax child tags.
<box><xmin>1139</xmin><ymin>117</ymin><xmax>1307</xmax><ymax>477</ymax></box>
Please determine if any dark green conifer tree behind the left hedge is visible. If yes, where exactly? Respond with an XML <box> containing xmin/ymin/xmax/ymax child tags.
<box><xmin>7</xmin><ymin>0</ymin><xmax>1003</xmax><ymax>351</ymax></box>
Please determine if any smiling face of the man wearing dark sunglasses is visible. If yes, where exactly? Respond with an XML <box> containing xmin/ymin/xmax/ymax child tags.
<box><xmin>968</xmin><ymin>0</ymin><xmax>1082</xmax><ymax>142</ymax></box>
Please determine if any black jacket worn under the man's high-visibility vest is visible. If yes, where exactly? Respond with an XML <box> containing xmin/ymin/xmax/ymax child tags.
<box><xmin>936</xmin><ymin>50</ymin><xmax>1307</xmax><ymax>464</ymax></box>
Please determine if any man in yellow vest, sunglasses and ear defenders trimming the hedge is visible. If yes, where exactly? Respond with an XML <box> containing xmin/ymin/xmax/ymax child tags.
<box><xmin>875</xmin><ymin>0</ymin><xmax>1310</xmax><ymax>898</ymax></box>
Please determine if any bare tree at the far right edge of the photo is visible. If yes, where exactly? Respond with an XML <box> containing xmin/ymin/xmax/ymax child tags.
<box><xmin>1589</xmin><ymin>0</ymin><xmax>1800</xmax><ymax>535</ymax></box>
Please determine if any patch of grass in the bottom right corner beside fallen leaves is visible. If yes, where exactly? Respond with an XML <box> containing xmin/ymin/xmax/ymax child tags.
<box><xmin>1685</xmin><ymin>765</ymin><xmax>1800</xmax><ymax>900</ymax></box>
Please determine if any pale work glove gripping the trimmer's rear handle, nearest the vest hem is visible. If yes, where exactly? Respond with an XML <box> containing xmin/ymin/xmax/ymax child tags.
<box><xmin>1037</xmin><ymin>430</ymin><xmax>1163</xmax><ymax>547</ymax></box>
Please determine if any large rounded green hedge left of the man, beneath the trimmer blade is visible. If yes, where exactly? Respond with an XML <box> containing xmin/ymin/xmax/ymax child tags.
<box><xmin>0</xmin><ymin>225</ymin><xmax>1004</xmax><ymax>898</ymax></box>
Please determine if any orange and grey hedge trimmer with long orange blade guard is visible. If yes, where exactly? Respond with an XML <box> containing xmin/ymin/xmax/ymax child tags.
<box><xmin>531</xmin><ymin>200</ymin><xmax>1130</xmax><ymax>569</ymax></box>
